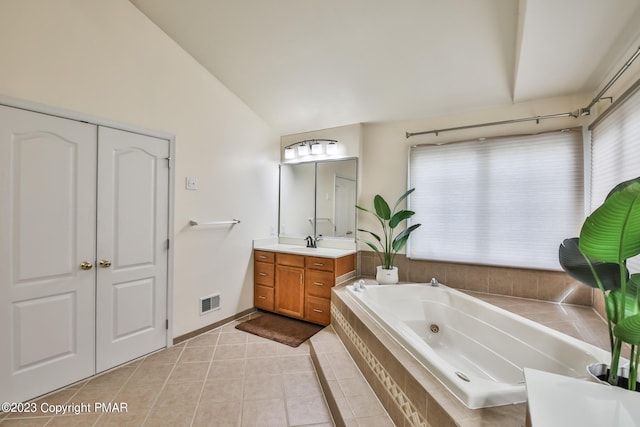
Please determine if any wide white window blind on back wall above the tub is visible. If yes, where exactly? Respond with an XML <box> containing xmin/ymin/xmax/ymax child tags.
<box><xmin>407</xmin><ymin>129</ymin><xmax>584</xmax><ymax>270</ymax></box>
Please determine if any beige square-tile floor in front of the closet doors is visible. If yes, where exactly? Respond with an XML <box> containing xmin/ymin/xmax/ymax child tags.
<box><xmin>0</xmin><ymin>315</ymin><xmax>334</xmax><ymax>427</ymax></box>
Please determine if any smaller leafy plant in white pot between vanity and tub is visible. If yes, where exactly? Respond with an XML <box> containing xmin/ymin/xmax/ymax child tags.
<box><xmin>356</xmin><ymin>188</ymin><xmax>421</xmax><ymax>283</ymax></box>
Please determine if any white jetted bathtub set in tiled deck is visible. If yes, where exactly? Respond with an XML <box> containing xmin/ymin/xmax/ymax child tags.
<box><xmin>347</xmin><ymin>284</ymin><xmax>610</xmax><ymax>409</ymax></box>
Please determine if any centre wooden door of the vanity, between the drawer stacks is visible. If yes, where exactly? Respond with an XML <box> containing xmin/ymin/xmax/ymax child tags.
<box><xmin>275</xmin><ymin>265</ymin><xmax>304</xmax><ymax>318</ymax></box>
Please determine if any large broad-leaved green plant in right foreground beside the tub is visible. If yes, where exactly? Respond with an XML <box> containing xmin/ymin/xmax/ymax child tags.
<box><xmin>559</xmin><ymin>177</ymin><xmax>640</xmax><ymax>390</ymax></box>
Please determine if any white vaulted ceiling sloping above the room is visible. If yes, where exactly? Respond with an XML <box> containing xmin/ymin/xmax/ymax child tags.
<box><xmin>131</xmin><ymin>0</ymin><xmax>640</xmax><ymax>134</ymax></box>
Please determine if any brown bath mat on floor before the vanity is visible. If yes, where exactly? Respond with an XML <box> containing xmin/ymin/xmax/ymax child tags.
<box><xmin>236</xmin><ymin>313</ymin><xmax>323</xmax><ymax>347</ymax></box>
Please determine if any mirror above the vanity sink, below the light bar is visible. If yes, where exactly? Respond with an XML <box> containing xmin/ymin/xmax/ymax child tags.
<box><xmin>279</xmin><ymin>159</ymin><xmax>357</xmax><ymax>240</ymax></box>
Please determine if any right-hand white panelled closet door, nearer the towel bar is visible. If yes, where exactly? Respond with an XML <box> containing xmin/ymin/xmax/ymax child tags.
<box><xmin>96</xmin><ymin>127</ymin><xmax>169</xmax><ymax>372</ymax></box>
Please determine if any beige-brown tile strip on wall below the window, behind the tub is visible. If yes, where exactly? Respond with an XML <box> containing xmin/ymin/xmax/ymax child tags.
<box><xmin>358</xmin><ymin>251</ymin><xmax>594</xmax><ymax>306</ymax></box>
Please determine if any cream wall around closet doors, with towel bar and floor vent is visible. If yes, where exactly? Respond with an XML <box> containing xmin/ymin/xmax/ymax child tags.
<box><xmin>0</xmin><ymin>0</ymin><xmax>279</xmax><ymax>336</ymax></box>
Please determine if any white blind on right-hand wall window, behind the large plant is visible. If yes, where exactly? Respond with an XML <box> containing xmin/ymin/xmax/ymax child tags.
<box><xmin>589</xmin><ymin>82</ymin><xmax>640</xmax><ymax>273</ymax></box>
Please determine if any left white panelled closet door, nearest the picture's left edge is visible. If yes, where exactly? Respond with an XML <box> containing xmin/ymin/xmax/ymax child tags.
<box><xmin>0</xmin><ymin>106</ymin><xmax>96</xmax><ymax>402</ymax></box>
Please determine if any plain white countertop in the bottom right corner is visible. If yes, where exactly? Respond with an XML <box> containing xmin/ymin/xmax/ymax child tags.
<box><xmin>524</xmin><ymin>368</ymin><xmax>640</xmax><ymax>427</ymax></box>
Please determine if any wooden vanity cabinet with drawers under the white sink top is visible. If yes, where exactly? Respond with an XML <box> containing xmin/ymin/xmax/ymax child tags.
<box><xmin>254</xmin><ymin>250</ymin><xmax>355</xmax><ymax>325</ymax></box>
